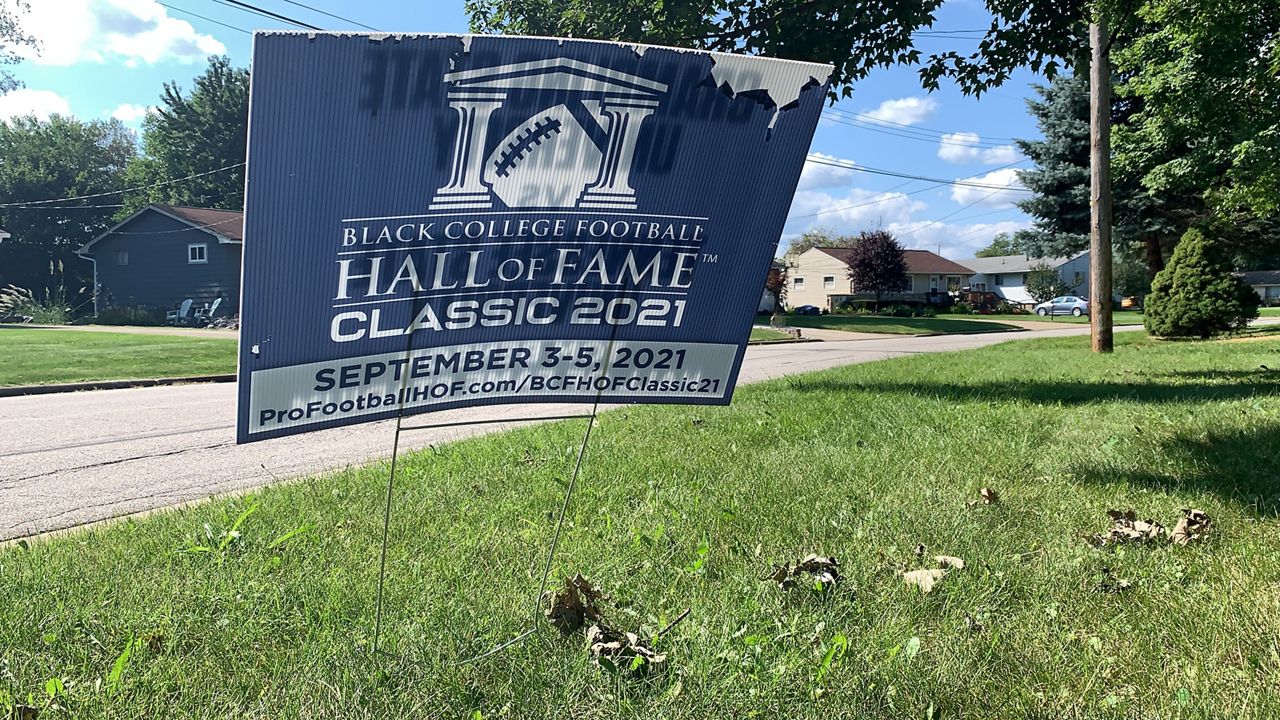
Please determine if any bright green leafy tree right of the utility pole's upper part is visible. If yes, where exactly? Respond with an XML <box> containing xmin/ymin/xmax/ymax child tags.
<box><xmin>1115</xmin><ymin>0</ymin><xmax>1280</xmax><ymax>223</ymax></box>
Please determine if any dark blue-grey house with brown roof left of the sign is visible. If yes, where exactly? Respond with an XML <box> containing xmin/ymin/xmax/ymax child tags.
<box><xmin>76</xmin><ymin>205</ymin><xmax>244</xmax><ymax>315</ymax></box>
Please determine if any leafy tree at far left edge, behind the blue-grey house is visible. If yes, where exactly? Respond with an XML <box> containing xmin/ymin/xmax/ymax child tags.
<box><xmin>0</xmin><ymin>115</ymin><xmax>136</xmax><ymax>305</ymax></box>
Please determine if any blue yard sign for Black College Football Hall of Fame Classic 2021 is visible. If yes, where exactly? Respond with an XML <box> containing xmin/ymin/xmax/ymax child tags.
<box><xmin>237</xmin><ymin>33</ymin><xmax>831</xmax><ymax>442</ymax></box>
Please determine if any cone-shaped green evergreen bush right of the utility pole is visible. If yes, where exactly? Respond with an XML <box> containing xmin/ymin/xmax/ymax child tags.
<box><xmin>1143</xmin><ymin>228</ymin><xmax>1260</xmax><ymax>338</ymax></box>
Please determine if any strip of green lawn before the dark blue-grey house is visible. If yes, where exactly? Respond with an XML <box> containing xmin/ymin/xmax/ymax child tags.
<box><xmin>0</xmin><ymin>328</ymin><xmax>236</xmax><ymax>387</ymax></box>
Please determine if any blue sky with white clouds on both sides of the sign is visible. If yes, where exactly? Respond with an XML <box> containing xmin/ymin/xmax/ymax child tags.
<box><xmin>0</xmin><ymin>0</ymin><xmax>1038</xmax><ymax>258</ymax></box>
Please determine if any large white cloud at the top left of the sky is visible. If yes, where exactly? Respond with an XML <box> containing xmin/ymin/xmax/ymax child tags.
<box><xmin>19</xmin><ymin>0</ymin><xmax>227</xmax><ymax>67</ymax></box>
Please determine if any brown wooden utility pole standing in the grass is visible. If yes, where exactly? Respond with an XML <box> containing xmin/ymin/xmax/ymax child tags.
<box><xmin>1089</xmin><ymin>17</ymin><xmax>1114</xmax><ymax>352</ymax></box>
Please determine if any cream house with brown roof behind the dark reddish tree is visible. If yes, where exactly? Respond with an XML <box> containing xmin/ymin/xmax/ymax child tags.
<box><xmin>787</xmin><ymin>247</ymin><xmax>973</xmax><ymax>310</ymax></box>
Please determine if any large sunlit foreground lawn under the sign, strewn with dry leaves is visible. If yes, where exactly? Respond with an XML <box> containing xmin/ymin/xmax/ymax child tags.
<box><xmin>0</xmin><ymin>333</ymin><xmax>1280</xmax><ymax>720</ymax></box>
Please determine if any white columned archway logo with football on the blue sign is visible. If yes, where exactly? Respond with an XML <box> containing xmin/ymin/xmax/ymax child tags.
<box><xmin>430</xmin><ymin>58</ymin><xmax>667</xmax><ymax>211</ymax></box>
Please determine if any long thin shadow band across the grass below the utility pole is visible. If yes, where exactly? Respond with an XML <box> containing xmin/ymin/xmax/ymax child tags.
<box><xmin>788</xmin><ymin>372</ymin><xmax>1280</xmax><ymax>405</ymax></box>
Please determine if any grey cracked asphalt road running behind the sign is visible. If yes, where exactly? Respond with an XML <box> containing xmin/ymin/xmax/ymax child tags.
<box><xmin>0</xmin><ymin>325</ymin><xmax>1111</xmax><ymax>541</ymax></box>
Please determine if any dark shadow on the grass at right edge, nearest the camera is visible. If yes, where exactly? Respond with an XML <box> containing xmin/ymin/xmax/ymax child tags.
<box><xmin>1071</xmin><ymin>424</ymin><xmax>1280</xmax><ymax>509</ymax></box>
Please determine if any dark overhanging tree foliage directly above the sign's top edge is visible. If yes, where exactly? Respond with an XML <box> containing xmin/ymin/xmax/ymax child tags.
<box><xmin>465</xmin><ymin>0</ymin><xmax>942</xmax><ymax>97</ymax></box>
